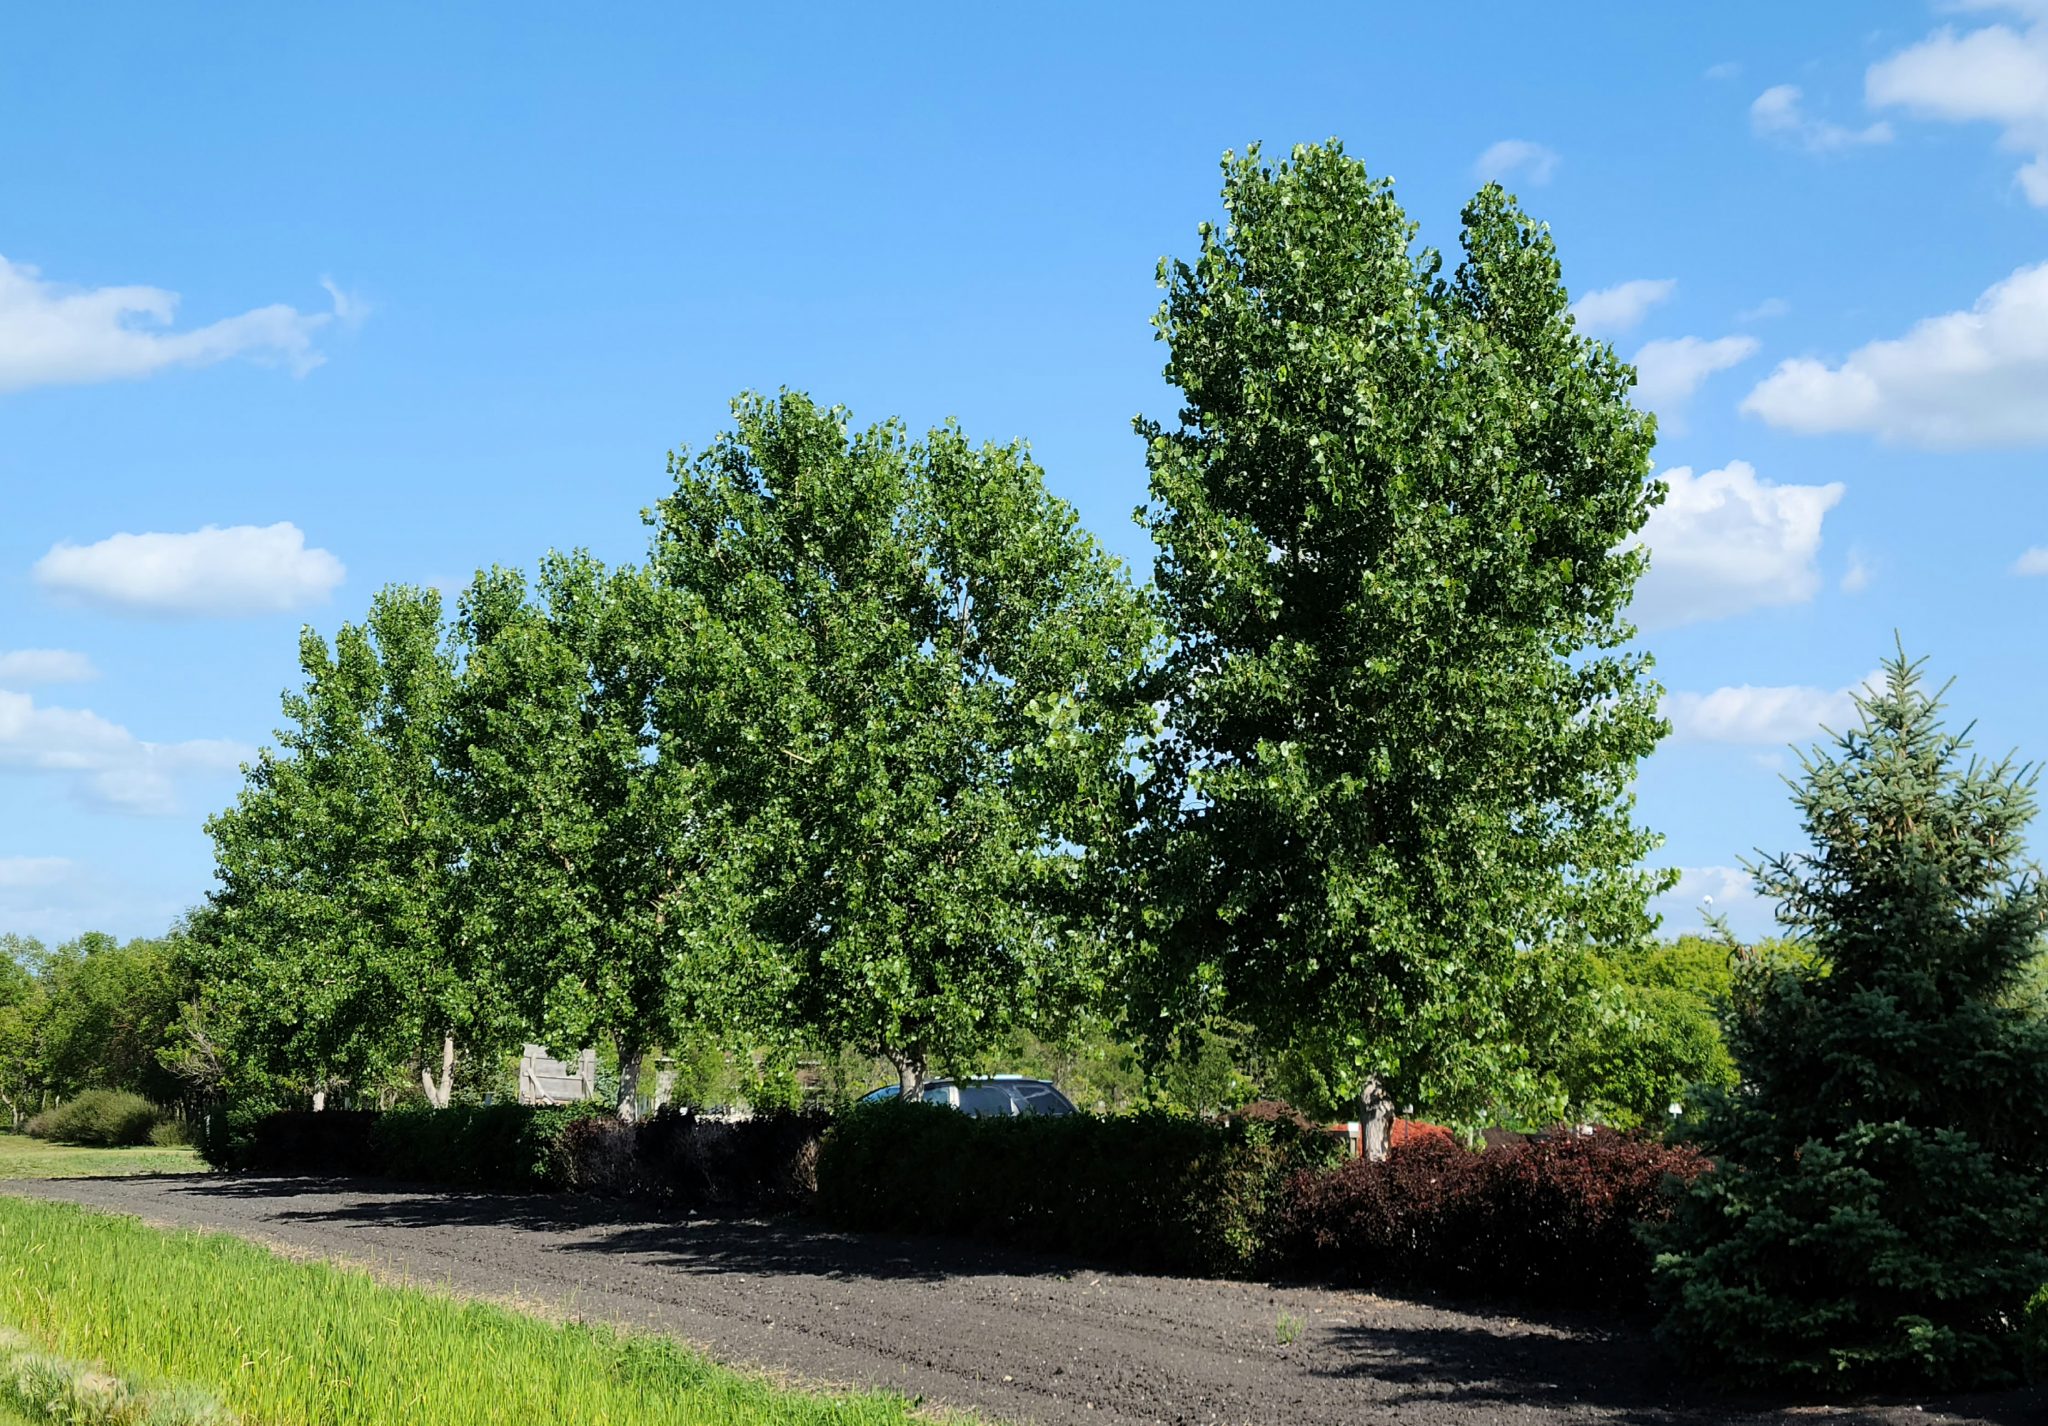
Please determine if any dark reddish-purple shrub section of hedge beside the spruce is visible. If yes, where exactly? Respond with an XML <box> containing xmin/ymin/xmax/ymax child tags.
<box><xmin>1274</xmin><ymin>1129</ymin><xmax>1708</xmax><ymax>1307</ymax></box>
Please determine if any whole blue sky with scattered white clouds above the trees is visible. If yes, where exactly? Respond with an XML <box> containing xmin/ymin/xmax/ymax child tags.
<box><xmin>0</xmin><ymin>0</ymin><xmax>2048</xmax><ymax>938</ymax></box>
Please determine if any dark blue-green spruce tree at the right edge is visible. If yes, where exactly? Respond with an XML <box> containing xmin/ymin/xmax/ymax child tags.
<box><xmin>1657</xmin><ymin>654</ymin><xmax>2048</xmax><ymax>1389</ymax></box>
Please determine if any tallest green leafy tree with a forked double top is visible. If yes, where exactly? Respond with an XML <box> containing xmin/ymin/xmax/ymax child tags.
<box><xmin>1133</xmin><ymin>143</ymin><xmax>1663</xmax><ymax>1129</ymax></box>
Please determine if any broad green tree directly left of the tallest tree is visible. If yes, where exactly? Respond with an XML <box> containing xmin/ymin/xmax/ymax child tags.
<box><xmin>655</xmin><ymin>393</ymin><xmax>1155</xmax><ymax>1092</ymax></box>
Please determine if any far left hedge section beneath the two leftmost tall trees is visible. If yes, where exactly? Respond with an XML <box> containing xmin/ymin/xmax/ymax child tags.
<box><xmin>199</xmin><ymin>1104</ymin><xmax>825</xmax><ymax>1211</ymax></box>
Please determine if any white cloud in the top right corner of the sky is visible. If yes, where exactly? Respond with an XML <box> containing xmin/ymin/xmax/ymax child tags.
<box><xmin>1864</xmin><ymin>2</ymin><xmax>2048</xmax><ymax>207</ymax></box>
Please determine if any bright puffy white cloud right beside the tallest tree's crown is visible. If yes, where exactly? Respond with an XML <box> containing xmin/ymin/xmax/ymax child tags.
<box><xmin>1632</xmin><ymin>461</ymin><xmax>1843</xmax><ymax>629</ymax></box>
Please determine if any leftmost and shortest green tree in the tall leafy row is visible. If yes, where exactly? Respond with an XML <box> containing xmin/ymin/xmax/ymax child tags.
<box><xmin>190</xmin><ymin>586</ymin><xmax>504</xmax><ymax>1096</ymax></box>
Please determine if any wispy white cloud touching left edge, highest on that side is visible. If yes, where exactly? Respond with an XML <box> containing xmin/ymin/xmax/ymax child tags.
<box><xmin>0</xmin><ymin>256</ymin><xmax>356</xmax><ymax>391</ymax></box>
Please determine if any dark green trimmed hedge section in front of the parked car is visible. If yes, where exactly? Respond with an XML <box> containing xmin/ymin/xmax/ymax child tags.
<box><xmin>817</xmin><ymin>1102</ymin><xmax>1341</xmax><ymax>1276</ymax></box>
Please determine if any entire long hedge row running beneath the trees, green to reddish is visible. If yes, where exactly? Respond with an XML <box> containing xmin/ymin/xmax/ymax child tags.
<box><xmin>201</xmin><ymin>1102</ymin><xmax>1708</xmax><ymax>1307</ymax></box>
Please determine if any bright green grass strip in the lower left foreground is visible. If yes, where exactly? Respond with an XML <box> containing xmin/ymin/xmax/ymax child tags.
<box><xmin>0</xmin><ymin>1199</ymin><xmax>937</xmax><ymax>1426</ymax></box>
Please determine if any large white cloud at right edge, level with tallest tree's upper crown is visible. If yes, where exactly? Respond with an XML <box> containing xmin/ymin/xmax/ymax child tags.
<box><xmin>1743</xmin><ymin>262</ymin><xmax>2048</xmax><ymax>449</ymax></box>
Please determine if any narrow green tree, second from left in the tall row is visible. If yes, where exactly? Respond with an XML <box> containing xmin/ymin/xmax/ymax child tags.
<box><xmin>451</xmin><ymin>553</ymin><xmax>696</xmax><ymax>1117</ymax></box>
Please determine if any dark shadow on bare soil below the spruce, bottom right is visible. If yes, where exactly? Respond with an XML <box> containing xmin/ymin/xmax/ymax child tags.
<box><xmin>1317</xmin><ymin>1319</ymin><xmax>2048</xmax><ymax>1426</ymax></box>
